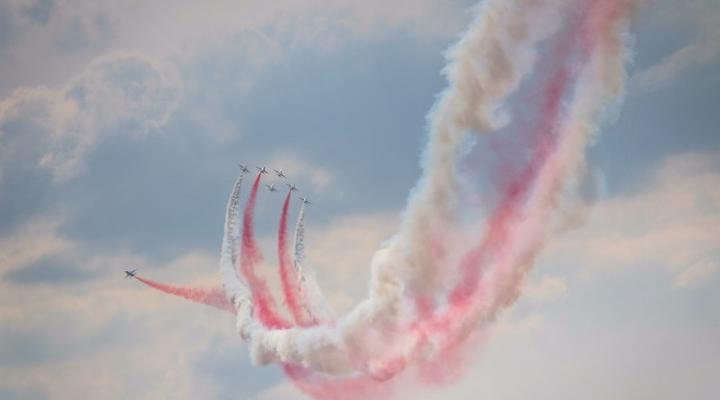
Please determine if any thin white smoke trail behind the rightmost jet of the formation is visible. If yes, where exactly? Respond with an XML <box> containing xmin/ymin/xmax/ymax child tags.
<box><xmin>293</xmin><ymin>201</ymin><xmax>335</xmax><ymax>323</ymax></box>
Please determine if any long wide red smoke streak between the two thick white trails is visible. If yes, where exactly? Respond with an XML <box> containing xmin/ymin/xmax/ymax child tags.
<box><xmin>420</xmin><ymin>3</ymin><xmax>600</xmax><ymax>383</ymax></box>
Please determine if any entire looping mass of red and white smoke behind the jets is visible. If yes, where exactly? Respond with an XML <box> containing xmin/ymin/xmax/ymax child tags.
<box><xmin>118</xmin><ymin>0</ymin><xmax>634</xmax><ymax>399</ymax></box>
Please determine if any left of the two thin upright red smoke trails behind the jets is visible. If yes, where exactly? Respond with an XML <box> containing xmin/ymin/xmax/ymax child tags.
<box><xmin>240</xmin><ymin>174</ymin><xmax>290</xmax><ymax>329</ymax></box>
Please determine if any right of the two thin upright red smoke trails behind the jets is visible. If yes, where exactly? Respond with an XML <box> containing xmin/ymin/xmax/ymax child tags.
<box><xmin>278</xmin><ymin>190</ymin><xmax>310</xmax><ymax>326</ymax></box>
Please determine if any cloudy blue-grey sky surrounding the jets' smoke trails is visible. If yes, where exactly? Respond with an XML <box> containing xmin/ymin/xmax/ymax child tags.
<box><xmin>0</xmin><ymin>0</ymin><xmax>720</xmax><ymax>400</ymax></box>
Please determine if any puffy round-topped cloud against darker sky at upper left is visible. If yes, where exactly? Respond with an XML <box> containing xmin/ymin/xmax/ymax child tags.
<box><xmin>0</xmin><ymin>54</ymin><xmax>181</xmax><ymax>181</ymax></box>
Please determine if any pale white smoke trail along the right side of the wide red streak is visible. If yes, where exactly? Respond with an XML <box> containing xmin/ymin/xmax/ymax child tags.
<box><xmin>414</xmin><ymin>1</ymin><xmax>633</xmax><ymax>366</ymax></box>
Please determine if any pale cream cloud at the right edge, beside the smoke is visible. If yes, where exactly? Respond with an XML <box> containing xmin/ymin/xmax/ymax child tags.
<box><xmin>545</xmin><ymin>154</ymin><xmax>720</xmax><ymax>287</ymax></box>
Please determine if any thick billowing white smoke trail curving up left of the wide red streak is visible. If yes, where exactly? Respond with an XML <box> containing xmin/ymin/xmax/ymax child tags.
<box><xmin>239</xmin><ymin>1</ymin><xmax>584</xmax><ymax>376</ymax></box>
